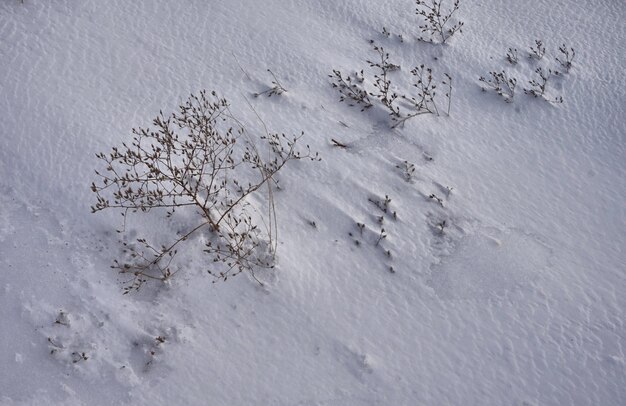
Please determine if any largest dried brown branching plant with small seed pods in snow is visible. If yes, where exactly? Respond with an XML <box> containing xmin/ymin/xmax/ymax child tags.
<box><xmin>91</xmin><ymin>91</ymin><xmax>319</xmax><ymax>293</ymax></box>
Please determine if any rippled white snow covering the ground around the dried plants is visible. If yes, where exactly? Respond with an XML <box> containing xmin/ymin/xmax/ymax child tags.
<box><xmin>0</xmin><ymin>0</ymin><xmax>626</xmax><ymax>405</ymax></box>
